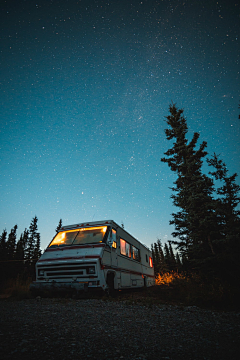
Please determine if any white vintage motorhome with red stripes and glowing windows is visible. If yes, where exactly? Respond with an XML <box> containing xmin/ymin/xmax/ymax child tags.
<box><xmin>30</xmin><ymin>220</ymin><xmax>155</xmax><ymax>292</ymax></box>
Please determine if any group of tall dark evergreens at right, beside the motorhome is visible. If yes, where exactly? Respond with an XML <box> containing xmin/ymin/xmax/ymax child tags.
<box><xmin>153</xmin><ymin>104</ymin><xmax>240</xmax><ymax>282</ymax></box>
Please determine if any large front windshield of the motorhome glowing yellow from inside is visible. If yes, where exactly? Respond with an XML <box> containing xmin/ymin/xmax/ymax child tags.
<box><xmin>49</xmin><ymin>226</ymin><xmax>107</xmax><ymax>247</ymax></box>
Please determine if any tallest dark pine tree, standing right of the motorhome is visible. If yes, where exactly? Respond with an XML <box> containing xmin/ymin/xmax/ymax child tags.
<box><xmin>161</xmin><ymin>104</ymin><xmax>217</xmax><ymax>266</ymax></box>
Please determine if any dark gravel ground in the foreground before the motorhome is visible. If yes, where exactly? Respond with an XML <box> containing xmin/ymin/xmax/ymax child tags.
<box><xmin>0</xmin><ymin>298</ymin><xmax>240</xmax><ymax>360</ymax></box>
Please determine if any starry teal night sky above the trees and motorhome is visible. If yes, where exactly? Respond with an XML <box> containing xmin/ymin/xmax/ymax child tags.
<box><xmin>0</xmin><ymin>0</ymin><xmax>240</xmax><ymax>249</ymax></box>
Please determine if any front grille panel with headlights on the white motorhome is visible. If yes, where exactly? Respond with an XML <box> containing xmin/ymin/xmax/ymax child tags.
<box><xmin>37</xmin><ymin>263</ymin><xmax>97</xmax><ymax>280</ymax></box>
